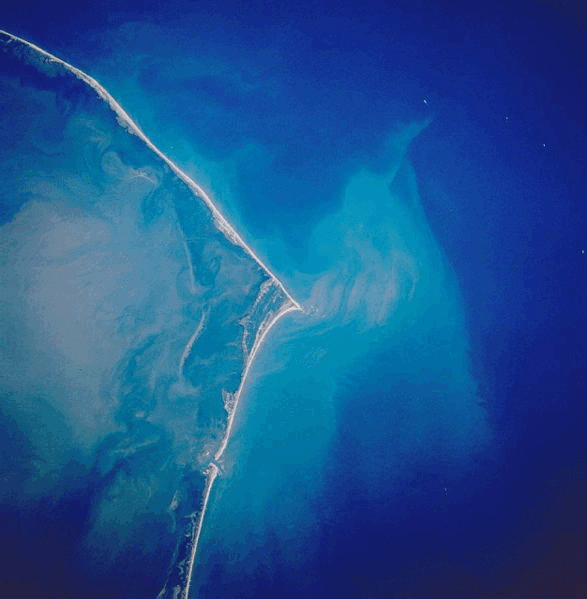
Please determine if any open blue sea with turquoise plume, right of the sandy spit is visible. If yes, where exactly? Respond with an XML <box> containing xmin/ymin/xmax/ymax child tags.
<box><xmin>0</xmin><ymin>1</ymin><xmax>587</xmax><ymax>599</ymax></box>
